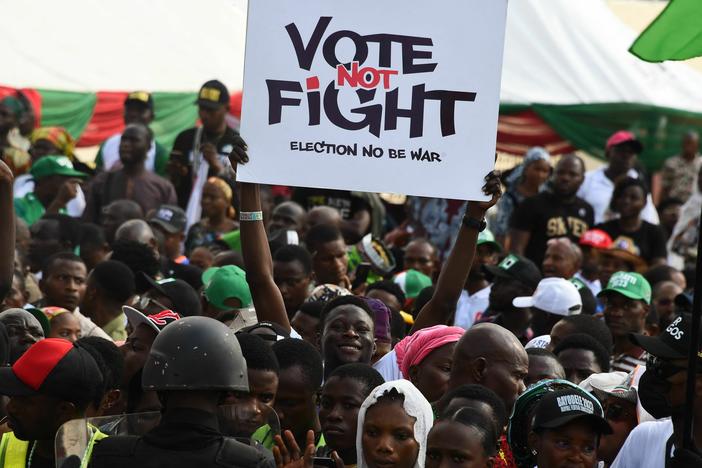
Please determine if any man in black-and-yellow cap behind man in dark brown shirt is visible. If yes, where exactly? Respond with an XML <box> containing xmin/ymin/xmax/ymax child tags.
<box><xmin>95</xmin><ymin>91</ymin><xmax>168</xmax><ymax>177</ymax></box>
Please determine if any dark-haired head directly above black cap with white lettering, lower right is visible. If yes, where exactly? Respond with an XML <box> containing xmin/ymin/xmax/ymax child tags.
<box><xmin>553</xmin><ymin>333</ymin><xmax>610</xmax><ymax>385</ymax></box>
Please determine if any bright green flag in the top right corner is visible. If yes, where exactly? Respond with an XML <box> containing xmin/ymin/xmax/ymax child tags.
<box><xmin>629</xmin><ymin>0</ymin><xmax>702</xmax><ymax>62</ymax></box>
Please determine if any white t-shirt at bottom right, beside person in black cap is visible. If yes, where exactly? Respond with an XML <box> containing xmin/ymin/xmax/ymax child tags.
<box><xmin>611</xmin><ymin>419</ymin><xmax>675</xmax><ymax>468</ymax></box>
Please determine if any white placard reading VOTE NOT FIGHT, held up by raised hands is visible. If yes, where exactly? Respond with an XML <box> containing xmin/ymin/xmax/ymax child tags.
<box><xmin>237</xmin><ymin>0</ymin><xmax>507</xmax><ymax>200</ymax></box>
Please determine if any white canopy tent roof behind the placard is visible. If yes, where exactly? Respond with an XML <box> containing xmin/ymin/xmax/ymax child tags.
<box><xmin>0</xmin><ymin>0</ymin><xmax>702</xmax><ymax>111</ymax></box>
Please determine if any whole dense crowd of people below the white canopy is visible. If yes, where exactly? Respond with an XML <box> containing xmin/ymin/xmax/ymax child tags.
<box><xmin>0</xmin><ymin>80</ymin><xmax>702</xmax><ymax>468</ymax></box>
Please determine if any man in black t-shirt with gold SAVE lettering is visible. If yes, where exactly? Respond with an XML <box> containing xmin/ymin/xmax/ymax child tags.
<box><xmin>510</xmin><ymin>155</ymin><xmax>593</xmax><ymax>265</ymax></box>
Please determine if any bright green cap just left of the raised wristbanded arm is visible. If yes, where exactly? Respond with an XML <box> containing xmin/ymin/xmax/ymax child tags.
<box><xmin>202</xmin><ymin>265</ymin><xmax>252</xmax><ymax>310</ymax></box>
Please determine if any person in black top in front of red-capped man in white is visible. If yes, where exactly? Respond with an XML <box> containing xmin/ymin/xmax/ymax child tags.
<box><xmin>595</xmin><ymin>177</ymin><xmax>667</xmax><ymax>266</ymax></box>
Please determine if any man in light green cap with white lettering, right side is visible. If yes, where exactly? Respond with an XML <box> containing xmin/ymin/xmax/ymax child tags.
<box><xmin>597</xmin><ymin>271</ymin><xmax>651</xmax><ymax>372</ymax></box>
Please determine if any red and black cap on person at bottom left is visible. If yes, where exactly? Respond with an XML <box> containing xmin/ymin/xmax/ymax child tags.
<box><xmin>0</xmin><ymin>338</ymin><xmax>102</xmax><ymax>401</ymax></box>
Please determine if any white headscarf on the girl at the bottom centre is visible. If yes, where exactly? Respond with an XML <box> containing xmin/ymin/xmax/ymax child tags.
<box><xmin>356</xmin><ymin>380</ymin><xmax>434</xmax><ymax>468</ymax></box>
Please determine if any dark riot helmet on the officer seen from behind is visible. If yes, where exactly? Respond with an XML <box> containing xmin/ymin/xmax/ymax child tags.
<box><xmin>142</xmin><ymin>317</ymin><xmax>249</xmax><ymax>392</ymax></box>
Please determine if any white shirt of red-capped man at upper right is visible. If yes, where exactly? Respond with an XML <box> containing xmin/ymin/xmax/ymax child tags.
<box><xmin>578</xmin><ymin>166</ymin><xmax>660</xmax><ymax>224</ymax></box>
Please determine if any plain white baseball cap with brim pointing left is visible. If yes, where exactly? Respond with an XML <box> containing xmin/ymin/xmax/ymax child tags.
<box><xmin>512</xmin><ymin>278</ymin><xmax>583</xmax><ymax>317</ymax></box>
